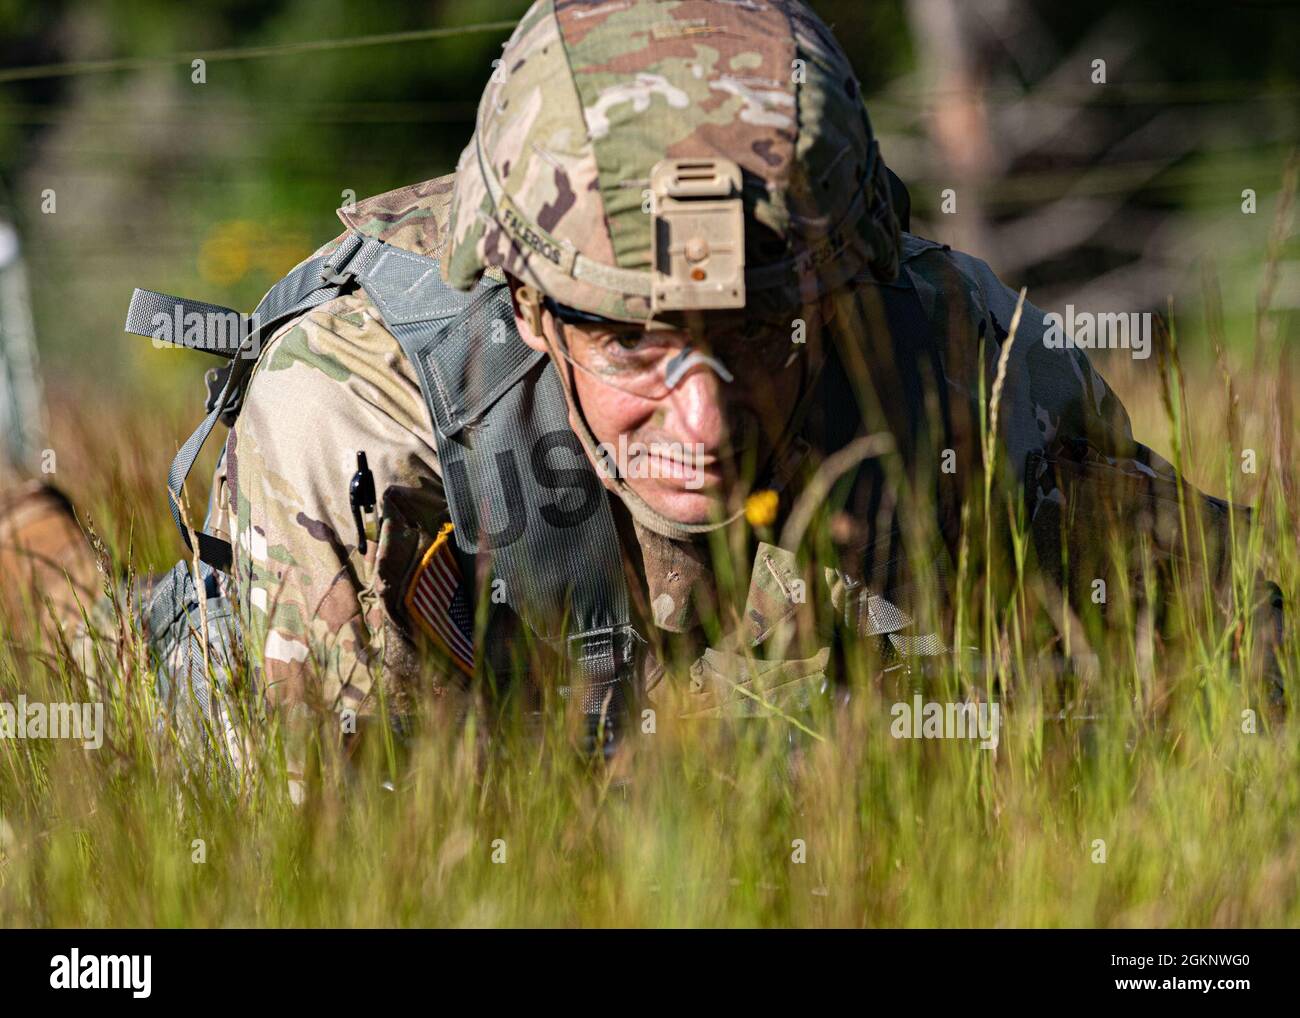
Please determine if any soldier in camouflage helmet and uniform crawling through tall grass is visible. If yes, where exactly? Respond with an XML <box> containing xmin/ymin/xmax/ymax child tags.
<box><xmin>0</xmin><ymin>0</ymin><xmax>1281</xmax><ymax>774</ymax></box>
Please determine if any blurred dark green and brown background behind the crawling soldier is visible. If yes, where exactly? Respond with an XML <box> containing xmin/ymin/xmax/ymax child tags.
<box><xmin>0</xmin><ymin>0</ymin><xmax>1300</xmax><ymax>533</ymax></box>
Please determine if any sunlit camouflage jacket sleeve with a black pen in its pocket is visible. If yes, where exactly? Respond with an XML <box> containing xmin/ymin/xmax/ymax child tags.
<box><xmin>218</xmin><ymin>177</ymin><xmax>467</xmax><ymax>715</ymax></box>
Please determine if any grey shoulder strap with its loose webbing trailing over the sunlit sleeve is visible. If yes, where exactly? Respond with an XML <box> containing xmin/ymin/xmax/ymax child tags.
<box><xmin>126</xmin><ymin>233</ymin><xmax>638</xmax><ymax>715</ymax></box>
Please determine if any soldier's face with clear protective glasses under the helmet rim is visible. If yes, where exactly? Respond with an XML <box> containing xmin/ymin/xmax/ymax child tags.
<box><xmin>506</xmin><ymin>284</ymin><xmax>805</xmax><ymax>523</ymax></box>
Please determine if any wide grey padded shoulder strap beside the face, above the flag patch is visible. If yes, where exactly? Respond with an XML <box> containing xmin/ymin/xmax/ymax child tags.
<box><xmin>358</xmin><ymin>247</ymin><xmax>637</xmax><ymax>716</ymax></box>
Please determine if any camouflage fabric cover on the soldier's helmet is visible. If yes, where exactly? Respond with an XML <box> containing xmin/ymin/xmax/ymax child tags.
<box><xmin>442</xmin><ymin>0</ymin><xmax>898</xmax><ymax>322</ymax></box>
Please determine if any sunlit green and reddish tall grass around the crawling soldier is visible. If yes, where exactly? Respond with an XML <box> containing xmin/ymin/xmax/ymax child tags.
<box><xmin>0</xmin><ymin>295</ymin><xmax>1300</xmax><ymax>927</ymax></box>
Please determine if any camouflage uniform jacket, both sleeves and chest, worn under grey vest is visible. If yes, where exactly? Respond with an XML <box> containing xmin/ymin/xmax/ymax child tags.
<box><xmin>213</xmin><ymin>169</ymin><xmax>1279</xmax><ymax>716</ymax></box>
